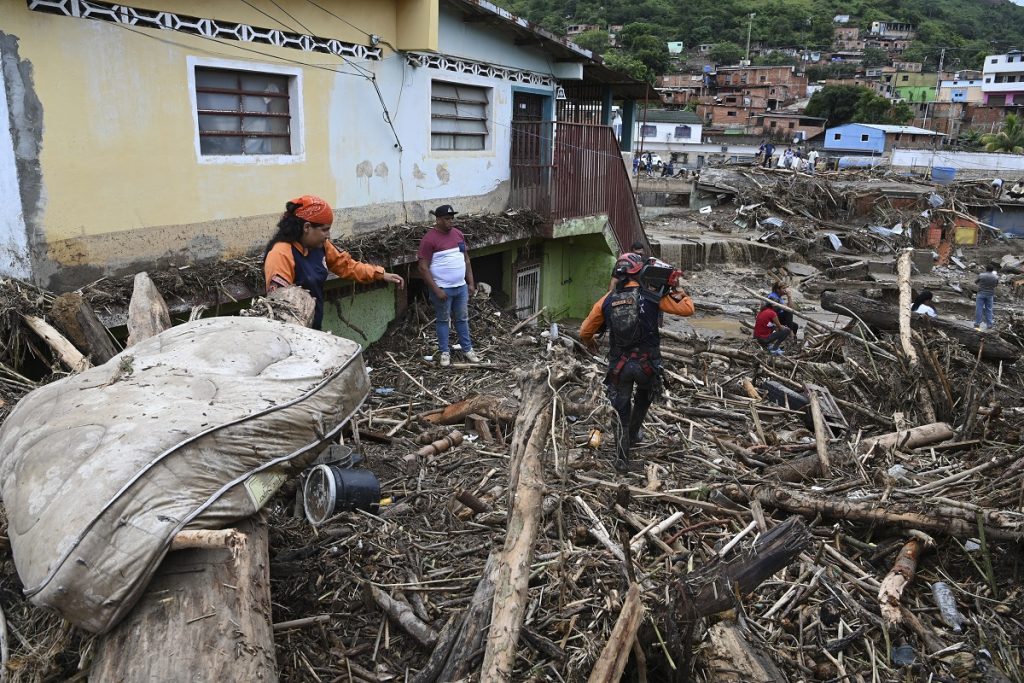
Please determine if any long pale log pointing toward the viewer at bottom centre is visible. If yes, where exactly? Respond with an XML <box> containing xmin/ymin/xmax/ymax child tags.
<box><xmin>472</xmin><ymin>362</ymin><xmax>567</xmax><ymax>682</ymax></box>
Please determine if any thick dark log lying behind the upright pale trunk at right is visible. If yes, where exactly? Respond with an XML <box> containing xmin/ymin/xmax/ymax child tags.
<box><xmin>821</xmin><ymin>291</ymin><xmax>1020</xmax><ymax>360</ymax></box>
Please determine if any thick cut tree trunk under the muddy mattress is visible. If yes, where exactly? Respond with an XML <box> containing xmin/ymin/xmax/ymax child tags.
<box><xmin>89</xmin><ymin>518</ymin><xmax>278</xmax><ymax>683</ymax></box>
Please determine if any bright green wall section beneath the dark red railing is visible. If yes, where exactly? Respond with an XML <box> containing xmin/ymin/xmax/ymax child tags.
<box><xmin>541</xmin><ymin>233</ymin><xmax>616</xmax><ymax>317</ymax></box>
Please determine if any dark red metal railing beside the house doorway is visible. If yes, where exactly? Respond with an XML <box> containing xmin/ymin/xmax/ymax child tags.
<box><xmin>509</xmin><ymin>121</ymin><xmax>647</xmax><ymax>251</ymax></box>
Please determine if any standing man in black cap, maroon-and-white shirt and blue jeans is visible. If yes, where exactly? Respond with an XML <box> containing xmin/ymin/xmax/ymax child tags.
<box><xmin>417</xmin><ymin>204</ymin><xmax>480</xmax><ymax>368</ymax></box>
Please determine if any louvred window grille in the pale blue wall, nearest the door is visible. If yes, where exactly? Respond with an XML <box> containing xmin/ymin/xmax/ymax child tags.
<box><xmin>430</xmin><ymin>81</ymin><xmax>489</xmax><ymax>151</ymax></box>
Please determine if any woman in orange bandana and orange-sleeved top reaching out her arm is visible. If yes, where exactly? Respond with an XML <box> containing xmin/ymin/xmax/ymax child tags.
<box><xmin>263</xmin><ymin>195</ymin><xmax>406</xmax><ymax>330</ymax></box>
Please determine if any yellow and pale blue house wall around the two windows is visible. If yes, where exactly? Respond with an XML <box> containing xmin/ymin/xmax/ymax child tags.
<box><xmin>0</xmin><ymin>0</ymin><xmax>551</xmax><ymax>290</ymax></box>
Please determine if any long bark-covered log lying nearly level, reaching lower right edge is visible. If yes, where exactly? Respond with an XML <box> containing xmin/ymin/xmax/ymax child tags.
<box><xmin>719</xmin><ymin>484</ymin><xmax>1024</xmax><ymax>541</ymax></box>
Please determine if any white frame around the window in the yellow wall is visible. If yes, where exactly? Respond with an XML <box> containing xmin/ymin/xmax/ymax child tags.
<box><xmin>185</xmin><ymin>56</ymin><xmax>306</xmax><ymax>166</ymax></box>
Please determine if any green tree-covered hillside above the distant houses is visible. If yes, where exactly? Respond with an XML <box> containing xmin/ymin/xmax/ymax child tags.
<box><xmin>500</xmin><ymin>0</ymin><xmax>1024</xmax><ymax>76</ymax></box>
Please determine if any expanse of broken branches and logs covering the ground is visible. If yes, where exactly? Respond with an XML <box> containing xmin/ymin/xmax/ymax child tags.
<box><xmin>0</xmin><ymin>179</ymin><xmax>1024</xmax><ymax>682</ymax></box>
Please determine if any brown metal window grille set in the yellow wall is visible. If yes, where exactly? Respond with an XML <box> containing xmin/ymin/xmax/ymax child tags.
<box><xmin>196</xmin><ymin>67</ymin><xmax>292</xmax><ymax>156</ymax></box>
